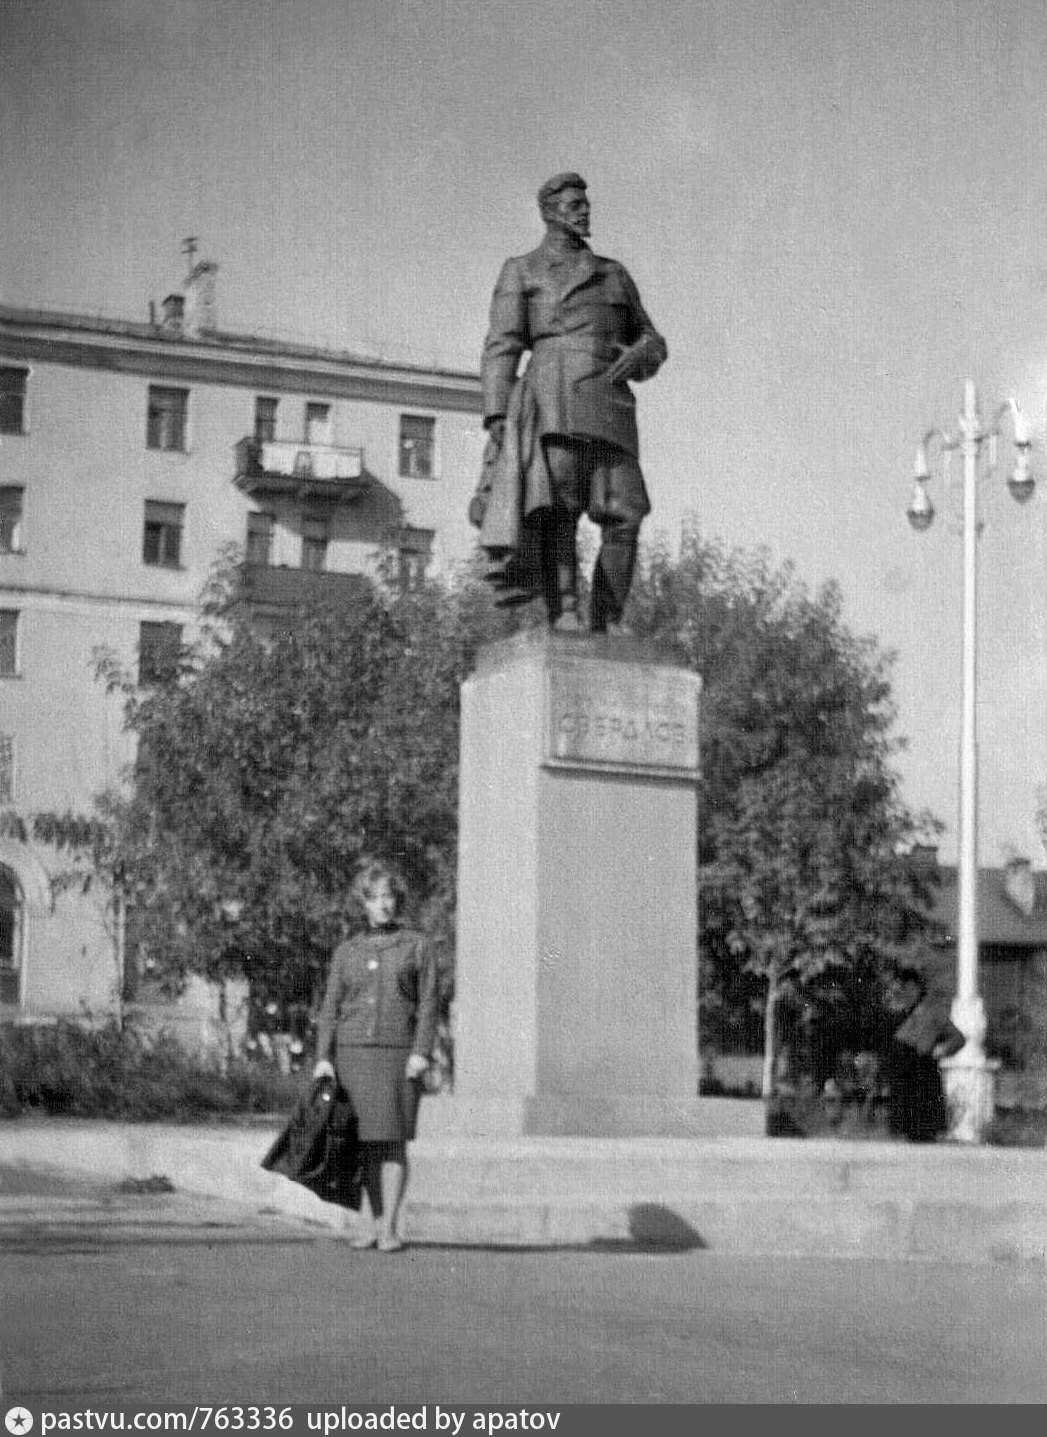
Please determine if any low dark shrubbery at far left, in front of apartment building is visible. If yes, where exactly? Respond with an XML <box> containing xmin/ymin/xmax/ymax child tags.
<box><xmin>0</xmin><ymin>1022</ymin><xmax>302</xmax><ymax>1122</ymax></box>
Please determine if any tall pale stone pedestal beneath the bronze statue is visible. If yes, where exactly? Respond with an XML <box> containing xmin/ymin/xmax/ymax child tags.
<box><xmin>454</xmin><ymin>631</ymin><xmax>699</xmax><ymax>1137</ymax></box>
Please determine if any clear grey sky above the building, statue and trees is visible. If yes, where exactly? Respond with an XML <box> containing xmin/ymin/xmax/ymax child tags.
<box><xmin>0</xmin><ymin>0</ymin><xmax>1047</xmax><ymax>867</ymax></box>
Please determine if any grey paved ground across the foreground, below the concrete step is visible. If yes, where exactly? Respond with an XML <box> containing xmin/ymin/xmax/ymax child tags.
<box><xmin>0</xmin><ymin>1170</ymin><xmax>1047</xmax><ymax>1408</ymax></box>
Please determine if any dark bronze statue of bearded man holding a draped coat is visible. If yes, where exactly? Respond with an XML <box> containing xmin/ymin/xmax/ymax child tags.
<box><xmin>471</xmin><ymin>172</ymin><xmax>668</xmax><ymax>634</ymax></box>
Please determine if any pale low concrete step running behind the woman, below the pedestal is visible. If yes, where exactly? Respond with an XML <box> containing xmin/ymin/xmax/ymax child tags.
<box><xmin>0</xmin><ymin>1097</ymin><xmax>1047</xmax><ymax>1262</ymax></box>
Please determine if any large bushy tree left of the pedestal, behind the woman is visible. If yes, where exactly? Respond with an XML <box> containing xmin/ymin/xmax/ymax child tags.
<box><xmin>33</xmin><ymin>554</ymin><xmax>517</xmax><ymax>996</ymax></box>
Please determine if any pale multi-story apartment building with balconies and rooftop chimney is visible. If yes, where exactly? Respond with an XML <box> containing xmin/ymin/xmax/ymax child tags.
<box><xmin>0</xmin><ymin>263</ymin><xmax>483</xmax><ymax>1016</ymax></box>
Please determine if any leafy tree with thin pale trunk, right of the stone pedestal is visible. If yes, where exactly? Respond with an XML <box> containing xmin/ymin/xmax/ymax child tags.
<box><xmin>633</xmin><ymin>533</ymin><xmax>934</xmax><ymax>1094</ymax></box>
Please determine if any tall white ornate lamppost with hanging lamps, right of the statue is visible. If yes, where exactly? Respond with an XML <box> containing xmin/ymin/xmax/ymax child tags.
<box><xmin>908</xmin><ymin>379</ymin><xmax>1036</xmax><ymax>1142</ymax></box>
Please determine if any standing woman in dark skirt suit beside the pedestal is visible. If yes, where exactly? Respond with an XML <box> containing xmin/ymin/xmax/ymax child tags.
<box><xmin>313</xmin><ymin>862</ymin><xmax>438</xmax><ymax>1253</ymax></box>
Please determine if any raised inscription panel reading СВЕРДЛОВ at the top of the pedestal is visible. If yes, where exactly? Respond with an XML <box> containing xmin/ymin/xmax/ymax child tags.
<box><xmin>546</xmin><ymin>658</ymin><xmax>699</xmax><ymax>775</ymax></box>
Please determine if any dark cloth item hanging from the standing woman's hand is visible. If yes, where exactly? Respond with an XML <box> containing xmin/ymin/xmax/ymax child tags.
<box><xmin>261</xmin><ymin>1078</ymin><xmax>363</xmax><ymax>1211</ymax></box>
